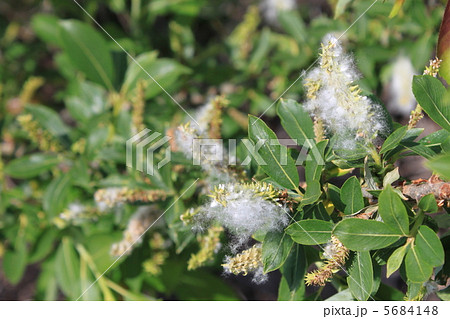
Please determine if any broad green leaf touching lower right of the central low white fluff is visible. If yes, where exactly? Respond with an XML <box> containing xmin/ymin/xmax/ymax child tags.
<box><xmin>262</xmin><ymin>232</ymin><xmax>294</xmax><ymax>273</ymax></box>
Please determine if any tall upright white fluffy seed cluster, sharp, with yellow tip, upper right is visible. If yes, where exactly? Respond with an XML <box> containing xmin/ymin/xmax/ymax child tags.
<box><xmin>304</xmin><ymin>35</ymin><xmax>385</xmax><ymax>148</ymax></box>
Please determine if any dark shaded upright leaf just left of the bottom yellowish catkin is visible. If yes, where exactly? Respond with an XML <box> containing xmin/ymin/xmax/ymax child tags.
<box><xmin>282</xmin><ymin>243</ymin><xmax>306</xmax><ymax>291</ymax></box>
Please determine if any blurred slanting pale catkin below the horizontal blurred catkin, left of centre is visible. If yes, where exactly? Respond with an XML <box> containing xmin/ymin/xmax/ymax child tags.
<box><xmin>110</xmin><ymin>206</ymin><xmax>156</xmax><ymax>257</ymax></box>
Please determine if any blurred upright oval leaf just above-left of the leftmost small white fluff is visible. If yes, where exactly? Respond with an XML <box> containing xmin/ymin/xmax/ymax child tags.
<box><xmin>42</xmin><ymin>173</ymin><xmax>72</xmax><ymax>219</ymax></box>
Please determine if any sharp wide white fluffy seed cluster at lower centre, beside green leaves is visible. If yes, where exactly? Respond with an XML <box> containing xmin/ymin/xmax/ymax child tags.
<box><xmin>196</xmin><ymin>184</ymin><xmax>289</xmax><ymax>250</ymax></box>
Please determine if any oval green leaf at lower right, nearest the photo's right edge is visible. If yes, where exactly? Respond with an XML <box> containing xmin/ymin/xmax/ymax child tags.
<box><xmin>414</xmin><ymin>225</ymin><xmax>444</xmax><ymax>267</ymax></box>
